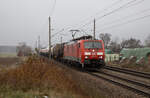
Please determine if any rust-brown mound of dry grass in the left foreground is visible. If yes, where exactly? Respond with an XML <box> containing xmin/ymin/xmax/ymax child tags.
<box><xmin>0</xmin><ymin>56</ymin><xmax>88</xmax><ymax>98</ymax></box>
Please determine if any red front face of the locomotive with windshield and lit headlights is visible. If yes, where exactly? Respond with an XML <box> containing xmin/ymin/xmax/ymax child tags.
<box><xmin>80</xmin><ymin>40</ymin><xmax>105</xmax><ymax>68</ymax></box>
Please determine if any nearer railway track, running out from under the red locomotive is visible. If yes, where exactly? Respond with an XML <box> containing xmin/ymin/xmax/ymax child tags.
<box><xmin>87</xmin><ymin>71</ymin><xmax>150</xmax><ymax>98</ymax></box>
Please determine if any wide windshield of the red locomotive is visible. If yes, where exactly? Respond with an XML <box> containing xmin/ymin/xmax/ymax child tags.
<box><xmin>84</xmin><ymin>41</ymin><xmax>102</xmax><ymax>49</ymax></box>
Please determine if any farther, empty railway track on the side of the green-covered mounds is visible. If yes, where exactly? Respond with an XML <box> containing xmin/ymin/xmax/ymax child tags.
<box><xmin>104</xmin><ymin>66</ymin><xmax>150</xmax><ymax>79</ymax></box>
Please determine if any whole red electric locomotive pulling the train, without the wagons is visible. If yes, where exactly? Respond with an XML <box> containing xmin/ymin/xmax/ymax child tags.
<box><xmin>63</xmin><ymin>35</ymin><xmax>105</xmax><ymax>68</ymax></box>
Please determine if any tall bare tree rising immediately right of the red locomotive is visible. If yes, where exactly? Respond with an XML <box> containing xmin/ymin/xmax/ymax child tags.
<box><xmin>99</xmin><ymin>33</ymin><xmax>111</xmax><ymax>48</ymax></box>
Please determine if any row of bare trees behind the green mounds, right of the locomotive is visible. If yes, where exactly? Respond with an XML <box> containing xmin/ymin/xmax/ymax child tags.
<box><xmin>99</xmin><ymin>33</ymin><xmax>150</xmax><ymax>53</ymax></box>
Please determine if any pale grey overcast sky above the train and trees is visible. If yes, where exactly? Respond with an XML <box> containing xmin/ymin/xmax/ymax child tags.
<box><xmin>0</xmin><ymin>0</ymin><xmax>150</xmax><ymax>46</ymax></box>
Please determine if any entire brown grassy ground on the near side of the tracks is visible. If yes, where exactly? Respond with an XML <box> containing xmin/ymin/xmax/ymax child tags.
<box><xmin>0</xmin><ymin>56</ymin><xmax>146</xmax><ymax>98</ymax></box>
